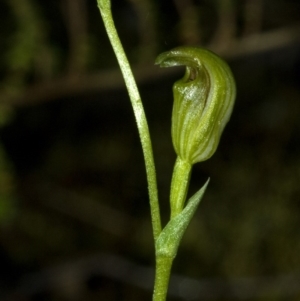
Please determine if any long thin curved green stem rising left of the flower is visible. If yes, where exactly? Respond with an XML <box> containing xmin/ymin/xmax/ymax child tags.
<box><xmin>97</xmin><ymin>0</ymin><xmax>161</xmax><ymax>241</ymax></box>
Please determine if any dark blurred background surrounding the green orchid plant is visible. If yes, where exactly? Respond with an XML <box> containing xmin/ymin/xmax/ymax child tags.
<box><xmin>0</xmin><ymin>0</ymin><xmax>300</xmax><ymax>301</ymax></box>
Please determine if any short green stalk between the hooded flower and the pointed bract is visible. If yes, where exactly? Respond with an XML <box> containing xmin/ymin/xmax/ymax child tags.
<box><xmin>170</xmin><ymin>157</ymin><xmax>192</xmax><ymax>219</ymax></box>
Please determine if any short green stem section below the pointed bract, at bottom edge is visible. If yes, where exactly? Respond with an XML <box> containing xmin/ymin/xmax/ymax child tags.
<box><xmin>152</xmin><ymin>256</ymin><xmax>173</xmax><ymax>301</ymax></box>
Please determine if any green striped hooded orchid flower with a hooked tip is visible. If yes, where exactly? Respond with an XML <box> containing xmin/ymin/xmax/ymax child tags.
<box><xmin>155</xmin><ymin>47</ymin><xmax>236</xmax><ymax>164</ymax></box>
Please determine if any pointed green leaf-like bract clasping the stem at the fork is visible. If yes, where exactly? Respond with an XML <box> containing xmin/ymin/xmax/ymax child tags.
<box><xmin>155</xmin><ymin>180</ymin><xmax>209</xmax><ymax>258</ymax></box>
